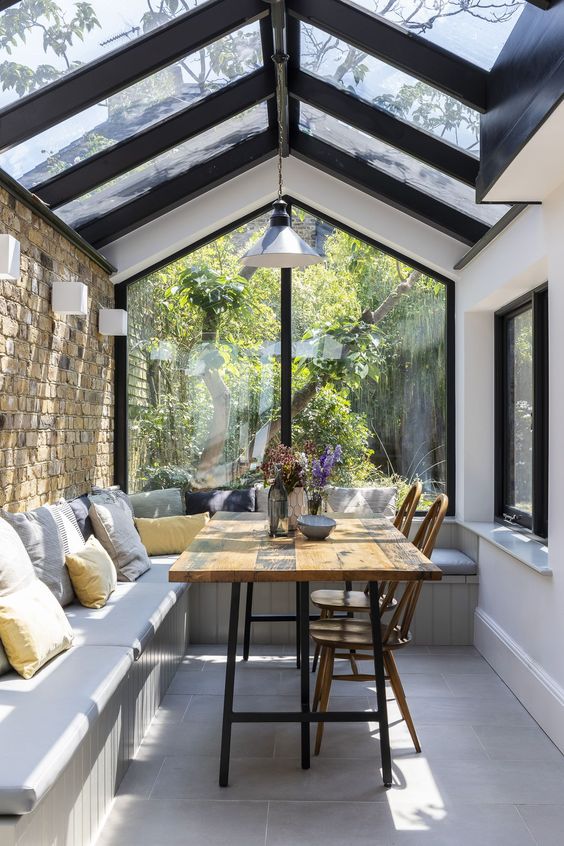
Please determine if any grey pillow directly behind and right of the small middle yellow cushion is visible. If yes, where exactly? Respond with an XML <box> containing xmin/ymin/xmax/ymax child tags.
<box><xmin>89</xmin><ymin>502</ymin><xmax>151</xmax><ymax>582</ymax></box>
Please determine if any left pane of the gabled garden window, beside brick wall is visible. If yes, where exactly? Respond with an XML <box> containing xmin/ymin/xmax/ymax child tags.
<box><xmin>128</xmin><ymin>210</ymin><xmax>280</xmax><ymax>491</ymax></box>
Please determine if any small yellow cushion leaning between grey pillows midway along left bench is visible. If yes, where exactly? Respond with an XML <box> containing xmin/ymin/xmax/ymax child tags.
<box><xmin>65</xmin><ymin>535</ymin><xmax>117</xmax><ymax>608</ymax></box>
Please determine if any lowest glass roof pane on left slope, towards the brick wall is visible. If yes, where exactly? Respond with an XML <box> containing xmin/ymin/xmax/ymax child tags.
<box><xmin>56</xmin><ymin>103</ymin><xmax>268</xmax><ymax>228</ymax></box>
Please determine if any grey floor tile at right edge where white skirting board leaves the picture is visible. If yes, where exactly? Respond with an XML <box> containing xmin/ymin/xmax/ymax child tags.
<box><xmin>474</xmin><ymin>725</ymin><xmax>564</xmax><ymax>764</ymax></box>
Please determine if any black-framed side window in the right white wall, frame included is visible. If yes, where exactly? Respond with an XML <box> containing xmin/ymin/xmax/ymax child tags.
<box><xmin>497</xmin><ymin>291</ymin><xmax>548</xmax><ymax>537</ymax></box>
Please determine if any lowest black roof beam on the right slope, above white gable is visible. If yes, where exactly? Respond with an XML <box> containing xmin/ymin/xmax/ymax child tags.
<box><xmin>290</xmin><ymin>130</ymin><xmax>488</xmax><ymax>246</ymax></box>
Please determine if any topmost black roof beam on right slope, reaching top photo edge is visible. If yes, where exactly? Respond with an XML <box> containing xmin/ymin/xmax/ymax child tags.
<box><xmin>287</xmin><ymin>0</ymin><xmax>488</xmax><ymax>112</ymax></box>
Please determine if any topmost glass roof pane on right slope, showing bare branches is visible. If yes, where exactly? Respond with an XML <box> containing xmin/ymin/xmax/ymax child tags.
<box><xmin>351</xmin><ymin>0</ymin><xmax>526</xmax><ymax>70</ymax></box>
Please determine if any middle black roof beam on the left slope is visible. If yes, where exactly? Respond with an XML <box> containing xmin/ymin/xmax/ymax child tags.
<box><xmin>32</xmin><ymin>70</ymin><xmax>274</xmax><ymax>206</ymax></box>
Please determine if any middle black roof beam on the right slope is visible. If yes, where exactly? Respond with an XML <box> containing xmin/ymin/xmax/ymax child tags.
<box><xmin>290</xmin><ymin>68</ymin><xmax>480</xmax><ymax>187</ymax></box>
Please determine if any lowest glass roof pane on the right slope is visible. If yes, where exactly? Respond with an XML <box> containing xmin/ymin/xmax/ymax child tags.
<box><xmin>299</xmin><ymin>103</ymin><xmax>509</xmax><ymax>226</ymax></box>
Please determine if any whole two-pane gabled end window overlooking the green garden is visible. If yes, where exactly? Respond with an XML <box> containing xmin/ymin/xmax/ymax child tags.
<box><xmin>128</xmin><ymin>208</ymin><xmax>448</xmax><ymax>510</ymax></box>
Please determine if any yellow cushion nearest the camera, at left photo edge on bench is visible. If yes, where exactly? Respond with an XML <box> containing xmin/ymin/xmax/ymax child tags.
<box><xmin>0</xmin><ymin>579</ymin><xmax>73</xmax><ymax>679</ymax></box>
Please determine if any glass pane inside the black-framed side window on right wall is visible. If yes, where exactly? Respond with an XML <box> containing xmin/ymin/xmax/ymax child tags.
<box><xmin>506</xmin><ymin>308</ymin><xmax>533</xmax><ymax>514</ymax></box>
